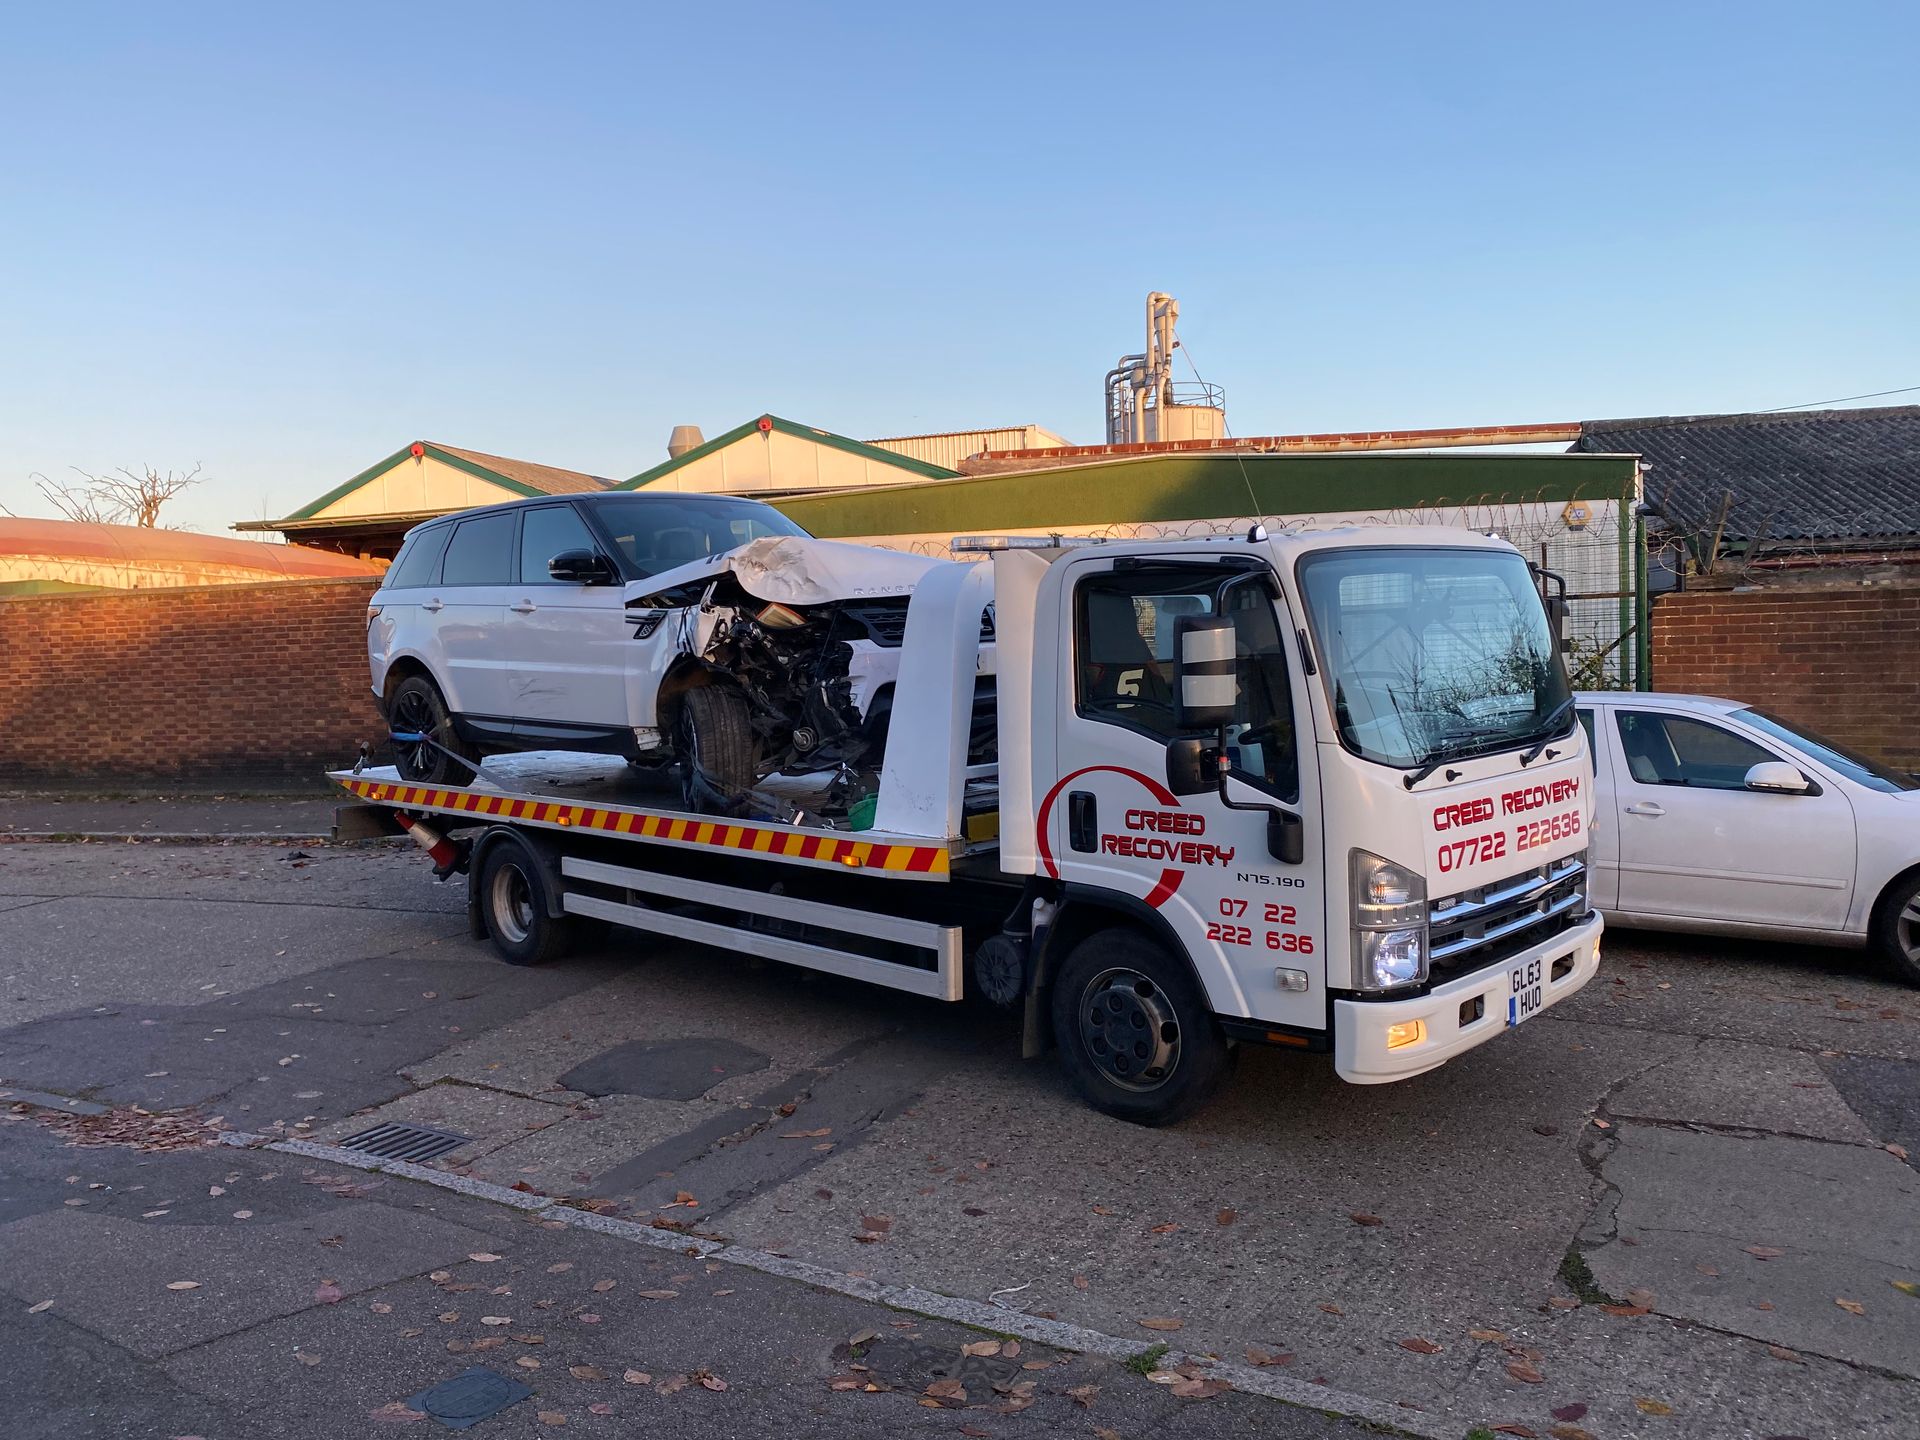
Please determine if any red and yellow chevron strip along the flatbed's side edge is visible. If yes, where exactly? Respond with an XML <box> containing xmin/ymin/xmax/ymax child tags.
<box><xmin>338</xmin><ymin>778</ymin><xmax>947</xmax><ymax>876</ymax></box>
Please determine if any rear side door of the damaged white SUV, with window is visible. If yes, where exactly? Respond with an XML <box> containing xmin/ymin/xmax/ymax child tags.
<box><xmin>420</xmin><ymin>511</ymin><xmax>520</xmax><ymax>739</ymax></box>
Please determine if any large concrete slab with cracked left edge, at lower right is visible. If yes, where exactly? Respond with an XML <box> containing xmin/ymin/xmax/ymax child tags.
<box><xmin>1586</xmin><ymin>1123</ymin><xmax>1920</xmax><ymax>1377</ymax></box>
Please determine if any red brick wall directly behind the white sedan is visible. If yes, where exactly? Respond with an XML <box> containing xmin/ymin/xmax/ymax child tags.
<box><xmin>1653</xmin><ymin>580</ymin><xmax>1920</xmax><ymax>770</ymax></box>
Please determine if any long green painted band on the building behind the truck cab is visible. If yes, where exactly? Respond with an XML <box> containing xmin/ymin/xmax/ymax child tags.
<box><xmin>774</xmin><ymin>453</ymin><xmax>1636</xmax><ymax>538</ymax></box>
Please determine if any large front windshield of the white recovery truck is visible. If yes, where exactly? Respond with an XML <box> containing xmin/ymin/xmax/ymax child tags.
<box><xmin>1300</xmin><ymin>547</ymin><xmax>1574</xmax><ymax>768</ymax></box>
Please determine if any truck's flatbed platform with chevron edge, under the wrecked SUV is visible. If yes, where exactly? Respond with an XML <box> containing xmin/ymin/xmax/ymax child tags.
<box><xmin>328</xmin><ymin>753</ymin><xmax>966</xmax><ymax>881</ymax></box>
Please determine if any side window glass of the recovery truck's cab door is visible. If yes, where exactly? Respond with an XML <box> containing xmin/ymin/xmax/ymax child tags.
<box><xmin>1073</xmin><ymin>566</ymin><xmax>1300</xmax><ymax>801</ymax></box>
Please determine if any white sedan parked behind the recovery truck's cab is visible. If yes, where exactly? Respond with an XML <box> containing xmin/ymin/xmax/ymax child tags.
<box><xmin>1576</xmin><ymin>691</ymin><xmax>1920</xmax><ymax>985</ymax></box>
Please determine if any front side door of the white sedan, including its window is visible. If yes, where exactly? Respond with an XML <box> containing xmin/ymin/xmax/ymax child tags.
<box><xmin>1611</xmin><ymin>705</ymin><xmax>1855</xmax><ymax>929</ymax></box>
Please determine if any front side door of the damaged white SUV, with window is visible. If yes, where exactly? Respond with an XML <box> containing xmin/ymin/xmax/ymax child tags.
<box><xmin>507</xmin><ymin>501</ymin><xmax>634</xmax><ymax>749</ymax></box>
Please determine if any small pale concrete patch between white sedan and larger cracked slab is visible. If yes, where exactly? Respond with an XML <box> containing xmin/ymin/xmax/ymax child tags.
<box><xmin>1607</xmin><ymin>1041</ymin><xmax>1874</xmax><ymax>1144</ymax></box>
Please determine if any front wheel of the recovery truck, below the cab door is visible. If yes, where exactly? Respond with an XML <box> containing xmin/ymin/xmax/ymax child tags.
<box><xmin>1052</xmin><ymin>929</ymin><xmax>1235</xmax><ymax>1125</ymax></box>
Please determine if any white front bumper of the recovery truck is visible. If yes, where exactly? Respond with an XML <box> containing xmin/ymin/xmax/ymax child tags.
<box><xmin>1332</xmin><ymin>912</ymin><xmax>1601</xmax><ymax>1085</ymax></box>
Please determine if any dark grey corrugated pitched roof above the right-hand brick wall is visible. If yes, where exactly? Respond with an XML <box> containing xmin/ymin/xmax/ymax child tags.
<box><xmin>1571</xmin><ymin>405</ymin><xmax>1920</xmax><ymax>541</ymax></box>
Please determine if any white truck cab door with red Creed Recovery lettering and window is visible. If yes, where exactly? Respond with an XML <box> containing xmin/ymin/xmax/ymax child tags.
<box><xmin>1037</xmin><ymin>555</ymin><xmax>1327</xmax><ymax>1031</ymax></box>
